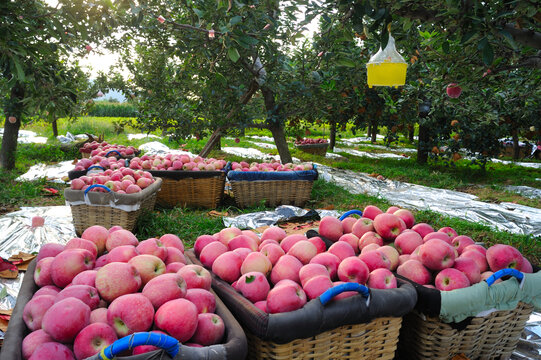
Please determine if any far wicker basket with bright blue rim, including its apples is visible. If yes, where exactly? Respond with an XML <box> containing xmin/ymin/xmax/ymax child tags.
<box><xmin>227</xmin><ymin>160</ymin><xmax>318</xmax><ymax>207</ymax></box>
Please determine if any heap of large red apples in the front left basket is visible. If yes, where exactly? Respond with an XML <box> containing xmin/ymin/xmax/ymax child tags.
<box><xmin>22</xmin><ymin>226</ymin><xmax>225</xmax><ymax>360</ymax></box>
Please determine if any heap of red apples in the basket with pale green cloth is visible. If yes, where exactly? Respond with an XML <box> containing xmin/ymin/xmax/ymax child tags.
<box><xmin>319</xmin><ymin>205</ymin><xmax>532</xmax><ymax>291</ymax></box>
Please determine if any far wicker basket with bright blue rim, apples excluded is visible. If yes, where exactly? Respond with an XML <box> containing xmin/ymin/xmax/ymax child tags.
<box><xmin>227</xmin><ymin>165</ymin><xmax>318</xmax><ymax>208</ymax></box>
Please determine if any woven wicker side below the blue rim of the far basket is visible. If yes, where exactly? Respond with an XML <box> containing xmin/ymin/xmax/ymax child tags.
<box><xmin>231</xmin><ymin>180</ymin><xmax>314</xmax><ymax>208</ymax></box>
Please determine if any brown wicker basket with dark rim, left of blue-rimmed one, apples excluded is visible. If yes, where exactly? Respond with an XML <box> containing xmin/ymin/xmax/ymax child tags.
<box><xmin>149</xmin><ymin>170</ymin><xmax>227</xmax><ymax>209</ymax></box>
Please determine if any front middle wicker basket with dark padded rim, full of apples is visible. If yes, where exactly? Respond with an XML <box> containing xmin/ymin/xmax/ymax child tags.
<box><xmin>186</xmin><ymin>225</ymin><xmax>417</xmax><ymax>359</ymax></box>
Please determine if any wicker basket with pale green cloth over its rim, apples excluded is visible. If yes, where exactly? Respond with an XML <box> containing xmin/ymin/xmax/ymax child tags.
<box><xmin>398</xmin><ymin>269</ymin><xmax>541</xmax><ymax>360</ymax></box>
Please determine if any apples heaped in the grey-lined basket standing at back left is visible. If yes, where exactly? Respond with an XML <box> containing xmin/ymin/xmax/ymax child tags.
<box><xmin>70</xmin><ymin>168</ymin><xmax>156</xmax><ymax>194</ymax></box>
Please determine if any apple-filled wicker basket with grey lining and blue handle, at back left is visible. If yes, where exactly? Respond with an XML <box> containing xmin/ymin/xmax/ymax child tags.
<box><xmin>64</xmin><ymin>168</ymin><xmax>162</xmax><ymax>234</ymax></box>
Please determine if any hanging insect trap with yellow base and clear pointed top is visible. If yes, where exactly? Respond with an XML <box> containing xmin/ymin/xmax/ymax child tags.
<box><xmin>366</xmin><ymin>33</ymin><xmax>408</xmax><ymax>88</ymax></box>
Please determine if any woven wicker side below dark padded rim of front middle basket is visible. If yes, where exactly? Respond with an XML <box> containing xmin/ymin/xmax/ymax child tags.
<box><xmin>245</xmin><ymin>317</ymin><xmax>402</xmax><ymax>360</ymax></box>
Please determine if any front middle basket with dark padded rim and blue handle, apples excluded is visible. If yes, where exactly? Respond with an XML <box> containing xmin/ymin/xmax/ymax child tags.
<box><xmin>185</xmin><ymin>250</ymin><xmax>417</xmax><ymax>360</ymax></box>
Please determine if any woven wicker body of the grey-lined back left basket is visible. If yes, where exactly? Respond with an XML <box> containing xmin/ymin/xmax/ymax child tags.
<box><xmin>66</xmin><ymin>179</ymin><xmax>162</xmax><ymax>236</ymax></box>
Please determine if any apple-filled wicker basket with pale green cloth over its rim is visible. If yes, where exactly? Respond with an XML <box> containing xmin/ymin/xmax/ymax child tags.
<box><xmin>332</xmin><ymin>205</ymin><xmax>541</xmax><ymax>359</ymax></box>
